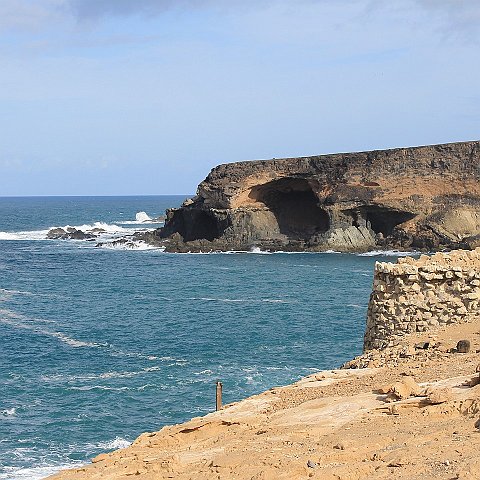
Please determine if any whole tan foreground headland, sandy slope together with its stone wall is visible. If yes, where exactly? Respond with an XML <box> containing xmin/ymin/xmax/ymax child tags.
<box><xmin>51</xmin><ymin>249</ymin><xmax>480</xmax><ymax>480</ymax></box>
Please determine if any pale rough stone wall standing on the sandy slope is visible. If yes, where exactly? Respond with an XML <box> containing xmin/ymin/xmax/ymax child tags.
<box><xmin>364</xmin><ymin>248</ymin><xmax>480</xmax><ymax>350</ymax></box>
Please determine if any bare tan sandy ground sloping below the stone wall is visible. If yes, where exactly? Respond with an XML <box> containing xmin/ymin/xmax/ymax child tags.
<box><xmin>50</xmin><ymin>320</ymin><xmax>480</xmax><ymax>480</ymax></box>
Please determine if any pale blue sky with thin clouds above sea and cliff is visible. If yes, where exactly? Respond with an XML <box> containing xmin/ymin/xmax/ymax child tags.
<box><xmin>0</xmin><ymin>0</ymin><xmax>480</xmax><ymax>196</ymax></box>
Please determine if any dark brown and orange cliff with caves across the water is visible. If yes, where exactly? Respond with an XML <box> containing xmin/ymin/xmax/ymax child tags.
<box><xmin>145</xmin><ymin>141</ymin><xmax>480</xmax><ymax>251</ymax></box>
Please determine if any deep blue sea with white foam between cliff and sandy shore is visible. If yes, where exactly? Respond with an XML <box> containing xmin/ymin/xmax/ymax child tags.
<box><xmin>0</xmin><ymin>196</ymin><xmax>408</xmax><ymax>480</ymax></box>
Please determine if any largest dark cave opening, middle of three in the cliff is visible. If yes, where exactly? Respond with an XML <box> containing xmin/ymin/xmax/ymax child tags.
<box><xmin>249</xmin><ymin>177</ymin><xmax>330</xmax><ymax>240</ymax></box>
